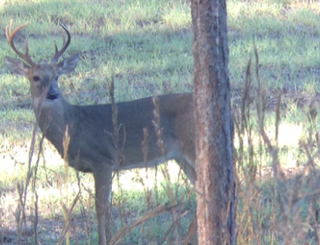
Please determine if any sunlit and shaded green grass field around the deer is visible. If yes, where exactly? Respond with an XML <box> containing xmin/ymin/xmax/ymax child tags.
<box><xmin>0</xmin><ymin>0</ymin><xmax>320</xmax><ymax>244</ymax></box>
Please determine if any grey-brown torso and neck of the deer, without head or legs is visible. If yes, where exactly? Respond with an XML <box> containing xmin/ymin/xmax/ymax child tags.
<box><xmin>38</xmin><ymin>94</ymin><xmax>195</xmax><ymax>176</ymax></box>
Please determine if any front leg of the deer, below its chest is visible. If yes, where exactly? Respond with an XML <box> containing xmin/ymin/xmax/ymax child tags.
<box><xmin>93</xmin><ymin>165</ymin><xmax>112</xmax><ymax>245</ymax></box>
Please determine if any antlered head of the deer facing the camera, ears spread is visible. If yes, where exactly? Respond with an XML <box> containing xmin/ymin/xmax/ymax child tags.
<box><xmin>5</xmin><ymin>21</ymin><xmax>79</xmax><ymax>109</ymax></box>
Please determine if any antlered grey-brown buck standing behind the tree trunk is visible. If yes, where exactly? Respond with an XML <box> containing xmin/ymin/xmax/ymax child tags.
<box><xmin>5</xmin><ymin>24</ymin><xmax>196</xmax><ymax>245</ymax></box>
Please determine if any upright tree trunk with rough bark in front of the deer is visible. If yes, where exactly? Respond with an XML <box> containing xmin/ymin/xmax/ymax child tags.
<box><xmin>191</xmin><ymin>0</ymin><xmax>236</xmax><ymax>245</ymax></box>
